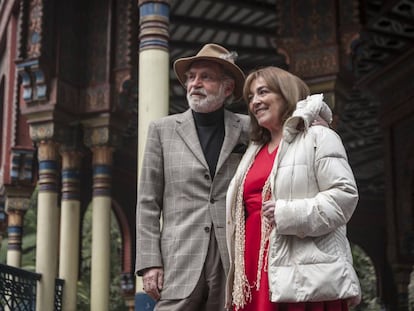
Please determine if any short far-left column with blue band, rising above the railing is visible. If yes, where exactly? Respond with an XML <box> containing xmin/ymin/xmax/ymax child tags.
<box><xmin>6</xmin><ymin>196</ymin><xmax>30</xmax><ymax>267</ymax></box>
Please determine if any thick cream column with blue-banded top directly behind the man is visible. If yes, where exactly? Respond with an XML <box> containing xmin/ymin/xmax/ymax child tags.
<box><xmin>138</xmin><ymin>0</ymin><xmax>170</xmax><ymax>166</ymax></box>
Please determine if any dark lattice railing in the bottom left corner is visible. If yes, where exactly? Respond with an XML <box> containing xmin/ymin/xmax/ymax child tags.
<box><xmin>0</xmin><ymin>264</ymin><xmax>64</xmax><ymax>311</ymax></box>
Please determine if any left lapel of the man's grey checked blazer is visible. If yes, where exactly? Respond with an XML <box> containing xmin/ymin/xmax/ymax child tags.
<box><xmin>177</xmin><ymin>109</ymin><xmax>208</xmax><ymax>169</ymax></box>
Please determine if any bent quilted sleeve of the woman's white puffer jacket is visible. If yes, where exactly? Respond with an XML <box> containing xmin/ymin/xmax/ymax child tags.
<box><xmin>275</xmin><ymin>126</ymin><xmax>358</xmax><ymax>238</ymax></box>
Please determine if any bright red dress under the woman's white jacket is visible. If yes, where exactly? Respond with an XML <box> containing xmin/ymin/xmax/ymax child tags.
<box><xmin>239</xmin><ymin>145</ymin><xmax>348</xmax><ymax>311</ymax></box>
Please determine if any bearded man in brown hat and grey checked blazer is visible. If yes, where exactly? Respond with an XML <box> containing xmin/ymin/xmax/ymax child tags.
<box><xmin>136</xmin><ymin>44</ymin><xmax>249</xmax><ymax>311</ymax></box>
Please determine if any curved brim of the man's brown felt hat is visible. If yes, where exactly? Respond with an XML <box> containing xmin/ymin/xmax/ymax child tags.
<box><xmin>174</xmin><ymin>56</ymin><xmax>245</xmax><ymax>101</ymax></box>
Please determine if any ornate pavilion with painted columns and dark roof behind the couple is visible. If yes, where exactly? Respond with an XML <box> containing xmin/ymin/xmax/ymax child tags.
<box><xmin>0</xmin><ymin>0</ymin><xmax>414</xmax><ymax>311</ymax></box>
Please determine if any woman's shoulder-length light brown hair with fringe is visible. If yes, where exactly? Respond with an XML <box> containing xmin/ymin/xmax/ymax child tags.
<box><xmin>243</xmin><ymin>66</ymin><xmax>310</xmax><ymax>144</ymax></box>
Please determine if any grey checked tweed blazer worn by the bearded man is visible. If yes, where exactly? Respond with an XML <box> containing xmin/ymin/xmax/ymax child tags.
<box><xmin>136</xmin><ymin>110</ymin><xmax>249</xmax><ymax>299</ymax></box>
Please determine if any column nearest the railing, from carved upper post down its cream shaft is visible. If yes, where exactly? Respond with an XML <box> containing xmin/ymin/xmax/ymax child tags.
<box><xmin>16</xmin><ymin>0</ymin><xmax>61</xmax><ymax>311</ymax></box>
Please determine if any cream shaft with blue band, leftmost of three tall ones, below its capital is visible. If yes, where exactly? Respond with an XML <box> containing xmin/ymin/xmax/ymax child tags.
<box><xmin>36</xmin><ymin>141</ymin><xmax>59</xmax><ymax>311</ymax></box>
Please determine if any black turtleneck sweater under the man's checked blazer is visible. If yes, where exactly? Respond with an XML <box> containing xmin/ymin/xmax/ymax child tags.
<box><xmin>193</xmin><ymin>107</ymin><xmax>224</xmax><ymax>178</ymax></box>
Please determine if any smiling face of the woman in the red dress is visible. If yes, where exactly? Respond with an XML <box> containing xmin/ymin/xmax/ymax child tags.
<box><xmin>248</xmin><ymin>77</ymin><xmax>286</xmax><ymax>133</ymax></box>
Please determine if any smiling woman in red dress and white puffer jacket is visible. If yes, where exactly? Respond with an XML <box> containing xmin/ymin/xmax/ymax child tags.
<box><xmin>226</xmin><ymin>67</ymin><xmax>361</xmax><ymax>311</ymax></box>
